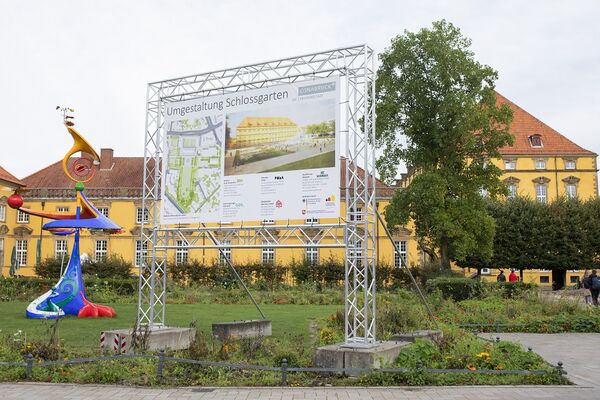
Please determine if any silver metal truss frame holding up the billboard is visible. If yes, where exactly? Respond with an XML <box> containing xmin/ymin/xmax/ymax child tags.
<box><xmin>137</xmin><ymin>45</ymin><xmax>377</xmax><ymax>347</ymax></box>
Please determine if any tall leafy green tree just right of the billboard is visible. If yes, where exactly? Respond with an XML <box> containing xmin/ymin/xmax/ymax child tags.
<box><xmin>376</xmin><ymin>21</ymin><xmax>512</xmax><ymax>269</ymax></box>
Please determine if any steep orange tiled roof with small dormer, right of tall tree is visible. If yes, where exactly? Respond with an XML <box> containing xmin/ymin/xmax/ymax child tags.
<box><xmin>496</xmin><ymin>93</ymin><xmax>597</xmax><ymax>156</ymax></box>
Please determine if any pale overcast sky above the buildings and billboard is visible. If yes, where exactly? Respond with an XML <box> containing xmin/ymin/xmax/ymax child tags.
<box><xmin>0</xmin><ymin>0</ymin><xmax>600</xmax><ymax>178</ymax></box>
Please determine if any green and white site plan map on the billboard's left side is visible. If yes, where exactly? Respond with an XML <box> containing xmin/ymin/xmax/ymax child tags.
<box><xmin>163</xmin><ymin>115</ymin><xmax>224</xmax><ymax>222</ymax></box>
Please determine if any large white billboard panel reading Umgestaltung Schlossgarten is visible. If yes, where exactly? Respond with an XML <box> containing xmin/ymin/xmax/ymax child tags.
<box><xmin>161</xmin><ymin>78</ymin><xmax>340</xmax><ymax>224</ymax></box>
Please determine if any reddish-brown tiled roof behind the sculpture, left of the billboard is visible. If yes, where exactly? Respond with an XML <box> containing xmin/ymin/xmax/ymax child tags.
<box><xmin>23</xmin><ymin>157</ymin><xmax>144</xmax><ymax>198</ymax></box>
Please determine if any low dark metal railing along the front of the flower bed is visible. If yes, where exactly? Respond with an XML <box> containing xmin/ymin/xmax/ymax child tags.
<box><xmin>0</xmin><ymin>348</ymin><xmax>567</xmax><ymax>386</ymax></box>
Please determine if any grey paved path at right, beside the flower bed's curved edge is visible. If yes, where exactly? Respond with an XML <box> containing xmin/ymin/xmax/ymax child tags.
<box><xmin>479</xmin><ymin>333</ymin><xmax>600</xmax><ymax>388</ymax></box>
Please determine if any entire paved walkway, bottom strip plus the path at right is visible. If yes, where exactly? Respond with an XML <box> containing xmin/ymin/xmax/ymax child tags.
<box><xmin>0</xmin><ymin>333</ymin><xmax>600</xmax><ymax>400</ymax></box>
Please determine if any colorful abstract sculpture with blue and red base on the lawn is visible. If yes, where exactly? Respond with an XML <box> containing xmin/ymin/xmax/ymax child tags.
<box><xmin>7</xmin><ymin>107</ymin><xmax>122</xmax><ymax>318</ymax></box>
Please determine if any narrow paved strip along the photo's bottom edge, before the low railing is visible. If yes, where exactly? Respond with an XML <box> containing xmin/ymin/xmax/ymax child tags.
<box><xmin>0</xmin><ymin>383</ymin><xmax>598</xmax><ymax>400</ymax></box>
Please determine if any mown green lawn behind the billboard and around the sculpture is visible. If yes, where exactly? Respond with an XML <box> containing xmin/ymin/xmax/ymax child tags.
<box><xmin>0</xmin><ymin>302</ymin><xmax>341</xmax><ymax>349</ymax></box>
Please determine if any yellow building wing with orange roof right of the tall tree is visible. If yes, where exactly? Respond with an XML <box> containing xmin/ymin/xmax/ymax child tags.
<box><xmin>472</xmin><ymin>94</ymin><xmax>598</xmax><ymax>286</ymax></box>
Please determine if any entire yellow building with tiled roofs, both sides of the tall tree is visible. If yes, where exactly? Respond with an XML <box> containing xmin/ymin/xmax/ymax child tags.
<box><xmin>0</xmin><ymin>95</ymin><xmax>598</xmax><ymax>286</ymax></box>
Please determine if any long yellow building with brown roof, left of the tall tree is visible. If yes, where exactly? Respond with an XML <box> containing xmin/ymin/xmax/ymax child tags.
<box><xmin>2</xmin><ymin>149</ymin><xmax>421</xmax><ymax>276</ymax></box>
